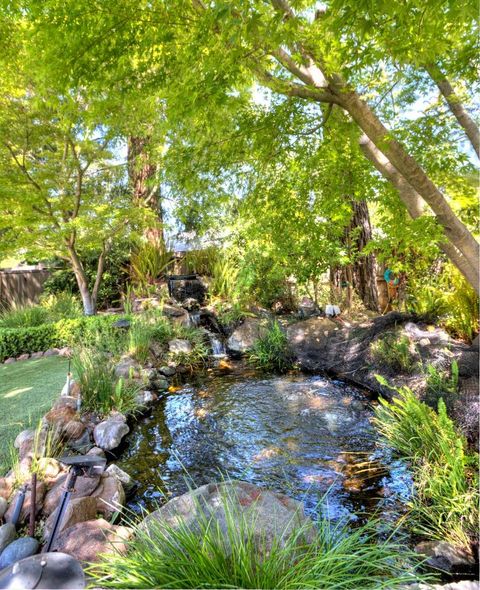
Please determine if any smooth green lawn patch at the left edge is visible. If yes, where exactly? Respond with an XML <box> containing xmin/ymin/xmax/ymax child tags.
<box><xmin>0</xmin><ymin>356</ymin><xmax>68</xmax><ymax>473</ymax></box>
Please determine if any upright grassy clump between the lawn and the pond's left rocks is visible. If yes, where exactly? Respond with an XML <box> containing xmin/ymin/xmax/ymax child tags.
<box><xmin>72</xmin><ymin>348</ymin><xmax>138</xmax><ymax>415</ymax></box>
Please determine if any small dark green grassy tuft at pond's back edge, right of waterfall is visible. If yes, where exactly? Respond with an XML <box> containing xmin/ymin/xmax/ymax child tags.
<box><xmin>247</xmin><ymin>321</ymin><xmax>293</xmax><ymax>373</ymax></box>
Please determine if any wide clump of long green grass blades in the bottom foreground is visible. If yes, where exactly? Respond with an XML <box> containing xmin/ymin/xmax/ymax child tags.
<box><xmin>88</xmin><ymin>498</ymin><xmax>430</xmax><ymax>590</ymax></box>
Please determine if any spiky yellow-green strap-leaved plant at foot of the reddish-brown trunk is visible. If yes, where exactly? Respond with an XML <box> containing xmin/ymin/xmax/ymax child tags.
<box><xmin>130</xmin><ymin>242</ymin><xmax>172</xmax><ymax>295</ymax></box>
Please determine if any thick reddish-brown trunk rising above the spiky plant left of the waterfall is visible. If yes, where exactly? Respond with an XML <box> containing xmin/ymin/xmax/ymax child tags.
<box><xmin>127</xmin><ymin>136</ymin><xmax>165</xmax><ymax>245</ymax></box>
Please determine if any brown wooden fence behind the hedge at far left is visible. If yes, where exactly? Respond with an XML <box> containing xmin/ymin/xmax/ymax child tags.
<box><xmin>0</xmin><ymin>269</ymin><xmax>50</xmax><ymax>308</ymax></box>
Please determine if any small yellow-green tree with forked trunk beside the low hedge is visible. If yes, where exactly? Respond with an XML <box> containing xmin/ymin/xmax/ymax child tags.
<box><xmin>0</xmin><ymin>86</ymin><xmax>146</xmax><ymax>315</ymax></box>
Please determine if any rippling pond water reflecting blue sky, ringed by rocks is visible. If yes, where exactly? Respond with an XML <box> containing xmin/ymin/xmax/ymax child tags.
<box><xmin>118</xmin><ymin>363</ymin><xmax>411</xmax><ymax>521</ymax></box>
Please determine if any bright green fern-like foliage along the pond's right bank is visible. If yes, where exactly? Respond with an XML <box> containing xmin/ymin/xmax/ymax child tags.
<box><xmin>374</xmin><ymin>379</ymin><xmax>480</xmax><ymax>551</ymax></box>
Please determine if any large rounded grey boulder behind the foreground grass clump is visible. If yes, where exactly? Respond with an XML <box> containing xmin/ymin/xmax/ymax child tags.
<box><xmin>141</xmin><ymin>481</ymin><xmax>314</xmax><ymax>552</ymax></box>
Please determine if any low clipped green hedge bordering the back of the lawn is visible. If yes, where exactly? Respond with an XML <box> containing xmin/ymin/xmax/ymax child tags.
<box><xmin>0</xmin><ymin>315</ymin><xmax>129</xmax><ymax>362</ymax></box>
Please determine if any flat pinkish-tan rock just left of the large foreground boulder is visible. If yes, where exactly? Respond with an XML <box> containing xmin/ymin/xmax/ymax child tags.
<box><xmin>53</xmin><ymin>518</ymin><xmax>133</xmax><ymax>563</ymax></box>
